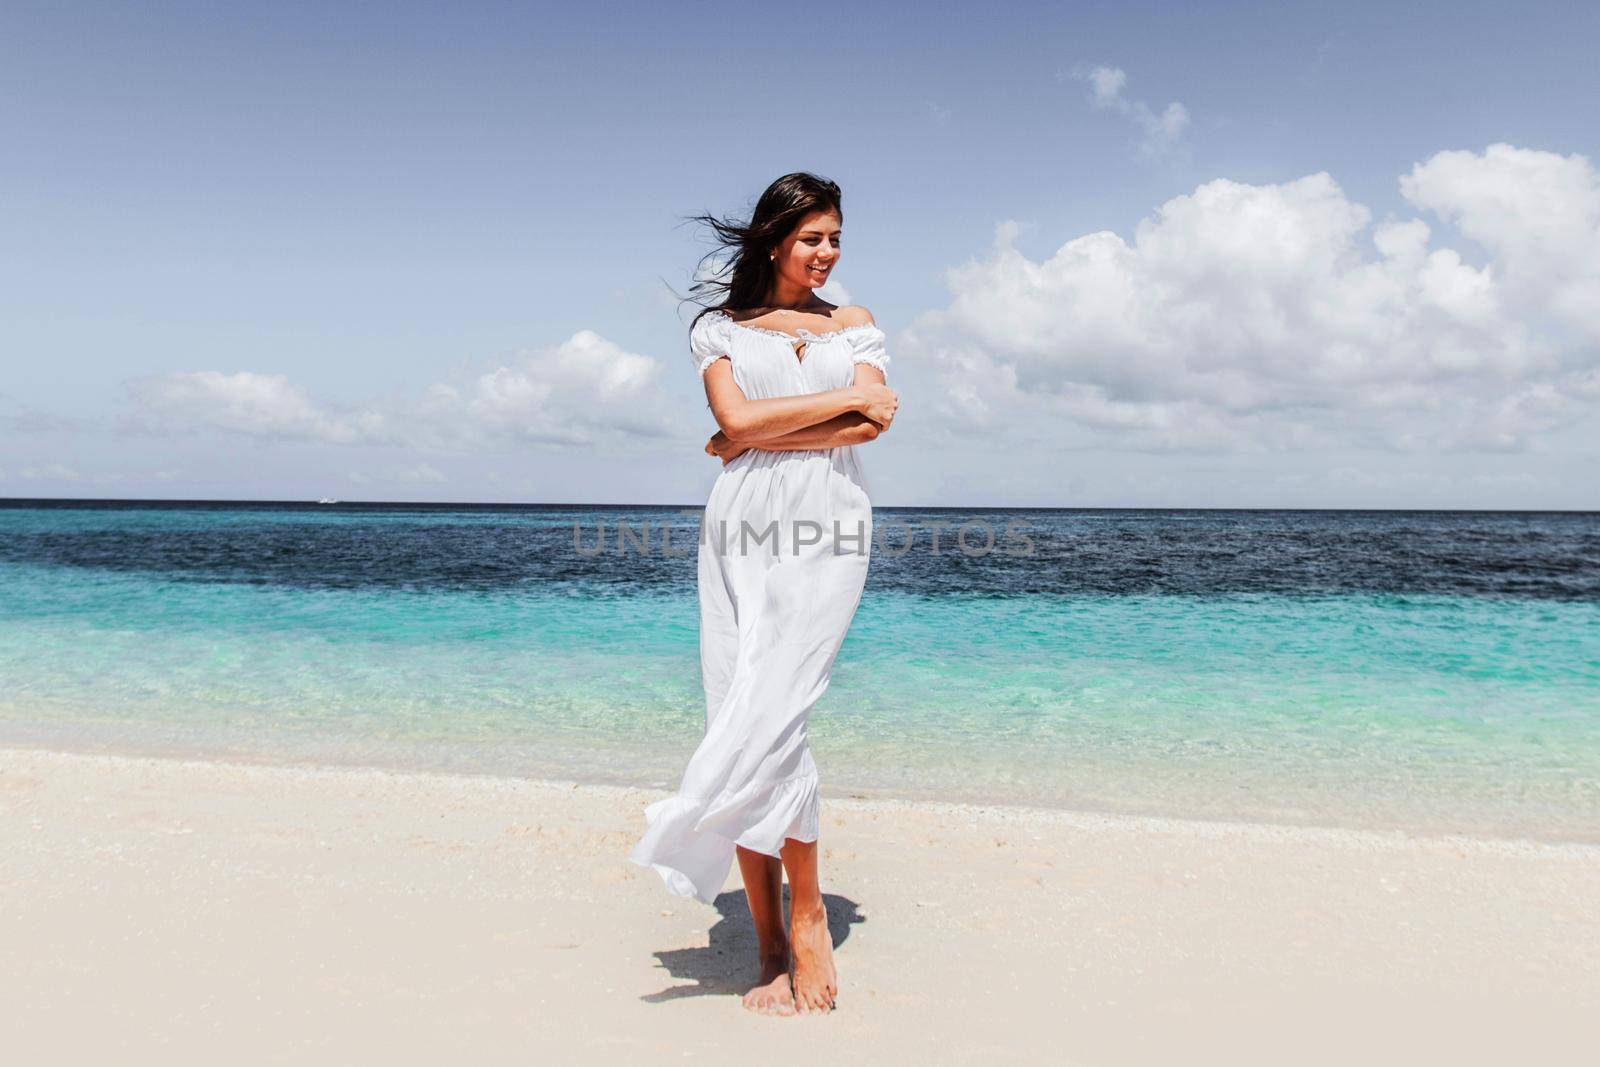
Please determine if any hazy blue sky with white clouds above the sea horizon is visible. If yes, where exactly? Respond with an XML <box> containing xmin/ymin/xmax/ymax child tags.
<box><xmin>0</xmin><ymin>3</ymin><xmax>1600</xmax><ymax>507</ymax></box>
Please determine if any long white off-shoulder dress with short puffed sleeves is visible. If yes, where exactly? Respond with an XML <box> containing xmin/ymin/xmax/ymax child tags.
<box><xmin>629</xmin><ymin>310</ymin><xmax>888</xmax><ymax>904</ymax></box>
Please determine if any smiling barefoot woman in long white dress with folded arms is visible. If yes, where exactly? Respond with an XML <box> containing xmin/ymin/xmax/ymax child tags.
<box><xmin>629</xmin><ymin>173</ymin><xmax>899</xmax><ymax>1014</ymax></box>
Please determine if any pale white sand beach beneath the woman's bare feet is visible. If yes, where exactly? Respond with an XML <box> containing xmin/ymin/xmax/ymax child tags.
<box><xmin>0</xmin><ymin>749</ymin><xmax>1600</xmax><ymax>1064</ymax></box>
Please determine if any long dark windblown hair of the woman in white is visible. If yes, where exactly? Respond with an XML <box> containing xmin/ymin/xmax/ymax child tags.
<box><xmin>683</xmin><ymin>171</ymin><xmax>845</xmax><ymax>330</ymax></box>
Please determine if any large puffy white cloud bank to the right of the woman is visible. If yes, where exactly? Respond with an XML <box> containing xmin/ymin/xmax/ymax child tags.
<box><xmin>899</xmin><ymin>143</ymin><xmax>1600</xmax><ymax>451</ymax></box>
